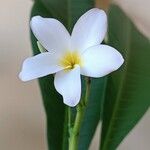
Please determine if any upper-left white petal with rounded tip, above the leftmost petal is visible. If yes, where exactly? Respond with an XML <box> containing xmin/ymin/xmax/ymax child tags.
<box><xmin>31</xmin><ymin>16</ymin><xmax>70</xmax><ymax>52</ymax></box>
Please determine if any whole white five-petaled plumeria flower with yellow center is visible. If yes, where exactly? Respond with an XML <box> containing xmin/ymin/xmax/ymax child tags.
<box><xmin>19</xmin><ymin>8</ymin><xmax>124</xmax><ymax>107</ymax></box>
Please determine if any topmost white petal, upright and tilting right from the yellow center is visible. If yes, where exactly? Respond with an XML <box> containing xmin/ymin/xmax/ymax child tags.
<box><xmin>71</xmin><ymin>8</ymin><xmax>107</xmax><ymax>52</ymax></box>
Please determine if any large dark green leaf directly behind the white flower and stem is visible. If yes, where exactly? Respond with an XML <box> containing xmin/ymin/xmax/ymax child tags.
<box><xmin>31</xmin><ymin>0</ymin><xmax>105</xmax><ymax>150</ymax></box>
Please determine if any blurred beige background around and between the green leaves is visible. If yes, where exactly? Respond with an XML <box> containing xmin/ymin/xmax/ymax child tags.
<box><xmin>0</xmin><ymin>0</ymin><xmax>150</xmax><ymax>150</ymax></box>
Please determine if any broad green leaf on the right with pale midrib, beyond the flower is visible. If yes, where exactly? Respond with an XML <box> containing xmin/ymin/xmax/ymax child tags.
<box><xmin>101</xmin><ymin>5</ymin><xmax>150</xmax><ymax>150</ymax></box>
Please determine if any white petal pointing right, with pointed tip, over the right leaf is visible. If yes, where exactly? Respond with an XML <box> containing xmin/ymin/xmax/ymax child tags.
<box><xmin>81</xmin><ymin>45</ymin><xmax>124</xmax><ymax>77</ymax></box>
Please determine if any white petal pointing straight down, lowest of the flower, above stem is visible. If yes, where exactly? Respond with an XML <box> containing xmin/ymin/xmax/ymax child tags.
<box><xmin>54</xmin><ymin>66</ymin><xmax>81</xmax><ymax>107</ymax></box>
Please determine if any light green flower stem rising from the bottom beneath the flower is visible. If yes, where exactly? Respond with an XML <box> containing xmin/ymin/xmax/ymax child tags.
<box><xmin>69</xmin><ymin>78</ymin><xmax>90</xmax><ymax>150</ymax></box>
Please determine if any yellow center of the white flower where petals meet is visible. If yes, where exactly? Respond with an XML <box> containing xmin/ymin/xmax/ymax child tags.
<box><xmin>60</xmin><ymin>51</ymin><xmax>81</xmax><ymax>70</ymax></box>
